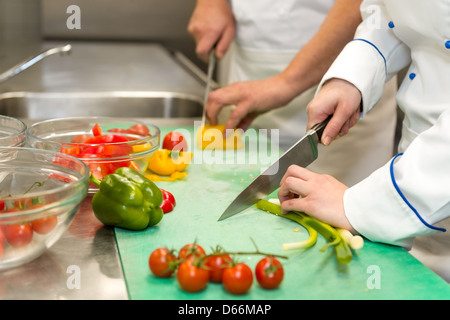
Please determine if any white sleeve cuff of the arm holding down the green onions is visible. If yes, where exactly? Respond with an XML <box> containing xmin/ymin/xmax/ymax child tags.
<box><xmin>344</xmin><ymin>159</ymin><xmax>436</xmax><ymax>249</ymax></box>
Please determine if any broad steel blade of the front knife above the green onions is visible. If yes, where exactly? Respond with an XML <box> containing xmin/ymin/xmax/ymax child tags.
<box><xmin>218</xmin><ymin>117</ymin><xmax>331</xmax><ymax>221</ymax></box>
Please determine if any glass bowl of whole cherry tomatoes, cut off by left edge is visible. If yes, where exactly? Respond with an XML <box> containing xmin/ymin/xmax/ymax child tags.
<box><xmin>0</xmin><ymin>147</ymin><xmax>89</xmax><ymax>270</ymax></box>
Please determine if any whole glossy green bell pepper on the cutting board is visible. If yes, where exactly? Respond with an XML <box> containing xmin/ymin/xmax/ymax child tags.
<box><xmin>90</xmin><ymin>167</ymin><xmax>163</xmax><ymax>230</ymax></box>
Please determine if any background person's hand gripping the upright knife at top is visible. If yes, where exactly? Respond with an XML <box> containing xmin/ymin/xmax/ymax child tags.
<box><xmin>187</xmin><ymin>0</ymin><xmax>236</xmax><ymax>62</ymax></box>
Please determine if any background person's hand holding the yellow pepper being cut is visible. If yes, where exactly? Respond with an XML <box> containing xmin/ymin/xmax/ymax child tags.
<box><xmin>206</xmin><ymin>74</ymin><xmax>297</xmax><ymax>131</ymax></box>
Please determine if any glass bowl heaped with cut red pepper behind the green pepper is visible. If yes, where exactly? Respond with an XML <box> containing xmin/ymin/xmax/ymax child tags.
<box><xmin>27</xmin><ymin>117</ymin><xmax>160</xmax><ymax>193</ymax></box>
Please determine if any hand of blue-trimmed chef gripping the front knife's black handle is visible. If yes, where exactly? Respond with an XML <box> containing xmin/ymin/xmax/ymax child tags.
<box><xmin>306</xmin><ymin>79</ymin><xmax>361</xmax><ymax>145</ymax></box>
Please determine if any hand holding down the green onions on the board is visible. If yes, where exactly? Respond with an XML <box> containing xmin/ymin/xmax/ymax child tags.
<box><xmin>278</xmin><ymin>165</ymin><xmax>354</xmax><ymax>231</ymax></box>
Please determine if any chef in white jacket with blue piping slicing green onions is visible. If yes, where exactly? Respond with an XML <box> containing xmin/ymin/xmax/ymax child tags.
<box><xmin>279</xmin><ymin>0</ymin><xmax>450</xmax><ymax>282</ymax></box>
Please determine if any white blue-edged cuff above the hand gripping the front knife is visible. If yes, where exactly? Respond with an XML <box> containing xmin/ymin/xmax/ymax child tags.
<box><xmin>317</xmin><ymin>39</ymin><xmax>386</xmax><ymax>118</ymax></box>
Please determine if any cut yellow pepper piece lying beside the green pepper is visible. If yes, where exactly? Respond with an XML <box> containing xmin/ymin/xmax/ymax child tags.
<box><xmin>148</xmin><ymin>149</ymin><xmax>193</xmax><ymax>176</ymax></box>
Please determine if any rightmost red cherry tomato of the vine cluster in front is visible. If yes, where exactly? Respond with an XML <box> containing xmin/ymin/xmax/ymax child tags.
<box><xmin>255</xmin><ymin>257</ymin><xmax>284</xmax><ymax>289</ymax></box>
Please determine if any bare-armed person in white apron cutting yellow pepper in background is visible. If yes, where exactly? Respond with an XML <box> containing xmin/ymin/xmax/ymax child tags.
<box><xmin>188</xmin><ymin>0</ymin><xmax>397</xmax><ymax>185</ymax></box>
